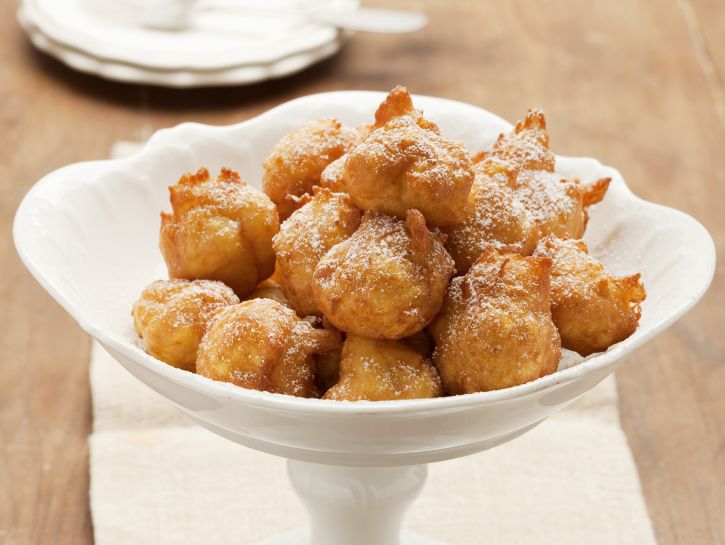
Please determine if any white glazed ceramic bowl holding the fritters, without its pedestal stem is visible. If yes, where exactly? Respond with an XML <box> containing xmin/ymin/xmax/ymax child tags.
<box><xmin>14</xmin><ymin>91</ymin><xmax>715</xmax><ymax>466</ymax></box>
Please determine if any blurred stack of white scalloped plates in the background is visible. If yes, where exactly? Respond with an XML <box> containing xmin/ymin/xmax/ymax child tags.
<box><xmin>18</xmin><ymin>0</ymin><xmax>358</xmax><ymax>87</ymax></box>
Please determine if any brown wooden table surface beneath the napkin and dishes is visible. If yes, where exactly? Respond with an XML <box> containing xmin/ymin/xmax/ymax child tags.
<box><xmin>0</xmin><ymin>0</ymin><xmax>725</xmax><ymax>545</ymax></box>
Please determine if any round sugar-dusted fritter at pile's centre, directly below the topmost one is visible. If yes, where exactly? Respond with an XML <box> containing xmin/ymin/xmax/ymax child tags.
<box><xmin>312</xmin><ymin>210</ymin><xmax>453</xmax><ymax>339</ymax></box>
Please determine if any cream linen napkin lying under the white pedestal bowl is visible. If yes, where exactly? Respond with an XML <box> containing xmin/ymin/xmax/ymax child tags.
<box><xmin>90</xmin><ymin>143</ymin><xmax>656</xmax><ymax>545</ymax></box>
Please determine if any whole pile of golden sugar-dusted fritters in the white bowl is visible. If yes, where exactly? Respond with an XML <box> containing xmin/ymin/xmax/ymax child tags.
<box><xmin>132</xmin><ymin>87</ymin><xmax>645</xmax><ymax>401</ymax></box>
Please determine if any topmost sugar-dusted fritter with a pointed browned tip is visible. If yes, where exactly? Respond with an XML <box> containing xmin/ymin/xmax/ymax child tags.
<box><xmin>343</xmin><ymin>87</ymin><xmax>473</xmax><ymax>227</ymax></box>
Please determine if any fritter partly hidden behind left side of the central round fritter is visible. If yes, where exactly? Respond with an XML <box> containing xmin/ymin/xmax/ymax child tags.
<box><xmin>273</xmin><ymin>187</ymin><xmax>362</xmax><ymax>316</ymax></box>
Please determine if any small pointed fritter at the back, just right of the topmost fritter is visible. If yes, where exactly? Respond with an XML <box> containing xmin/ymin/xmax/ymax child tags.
<box><xmin>473</xmin><ymin>109</ymin><xmax>555</xmax><ymax>172</ymax></box>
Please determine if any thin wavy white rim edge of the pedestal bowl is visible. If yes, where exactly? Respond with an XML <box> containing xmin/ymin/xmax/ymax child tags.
<box><xmin>13</xmin><ymin>91</ymin><xmax>716</xmax><ymax>416</ymax></box>
